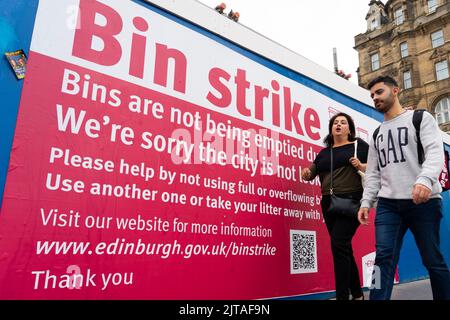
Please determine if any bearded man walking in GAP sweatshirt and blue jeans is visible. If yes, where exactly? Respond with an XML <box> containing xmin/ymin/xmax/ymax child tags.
<box><xmin>358</xmin><ymin>76</ymin><xmax>450</xmax><ymax>300</ymax></box>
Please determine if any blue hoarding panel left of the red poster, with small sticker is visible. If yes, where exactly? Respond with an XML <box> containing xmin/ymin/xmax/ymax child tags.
<box><xmin>0</xmin><ymin>0</ymin><xmax>38</xmax><ymax>205</ymax></box>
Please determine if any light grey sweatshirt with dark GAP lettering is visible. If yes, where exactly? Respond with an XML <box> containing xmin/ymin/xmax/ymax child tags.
<box><xmin>361</xmin><ymin>110</ymin><xmax>445</xmax><ymax>208</ymax></box>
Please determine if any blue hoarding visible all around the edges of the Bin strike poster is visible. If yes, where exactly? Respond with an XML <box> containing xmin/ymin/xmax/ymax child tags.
<box><xmin>0</xmin><ymin>0</ymin><xmax>450</xmax><ymax>300</ymax></box>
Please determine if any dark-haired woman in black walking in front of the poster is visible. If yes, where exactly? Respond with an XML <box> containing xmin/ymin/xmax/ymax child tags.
<box><xmin>302</xmin><ymin>113</ymin><xmax>369</xmax><ymax>300</ymax></box>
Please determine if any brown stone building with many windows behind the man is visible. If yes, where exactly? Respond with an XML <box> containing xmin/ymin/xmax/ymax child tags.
<box><xmin>355</xmin><ymin>0</ymin><xmax>450</xmax><ymax>133</ymax></box>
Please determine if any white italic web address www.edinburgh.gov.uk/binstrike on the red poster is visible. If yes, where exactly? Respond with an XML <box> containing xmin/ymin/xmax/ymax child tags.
<box><xmin>36</xmin><ymin>238</ymin><xmax>277</xmax><ymax>259</ymax></box>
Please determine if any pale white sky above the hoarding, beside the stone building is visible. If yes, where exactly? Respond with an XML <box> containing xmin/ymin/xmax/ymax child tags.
<box><xmin>198</xmin><ymin>0</ymin><xmax>378</xmax><ymax>84</ymax></box>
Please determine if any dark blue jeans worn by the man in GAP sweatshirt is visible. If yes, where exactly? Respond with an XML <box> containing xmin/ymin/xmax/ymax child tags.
<box><xmin>370</xmin><ymin>198</ymin><xmax>450</xmax><ymax>300</ymax></box>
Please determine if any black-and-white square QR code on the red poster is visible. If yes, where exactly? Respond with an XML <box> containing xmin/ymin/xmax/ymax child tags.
<box><xmin>291</xmin><ymin>230</ymin><xmax>317</xmax><ymax>274</ymax></box>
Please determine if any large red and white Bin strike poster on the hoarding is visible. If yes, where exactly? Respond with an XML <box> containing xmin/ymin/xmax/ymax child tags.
<box><xmin>0</xmin><ymin>0</ymin><xmax>377</xmax><ymax>299</ymax></box>
